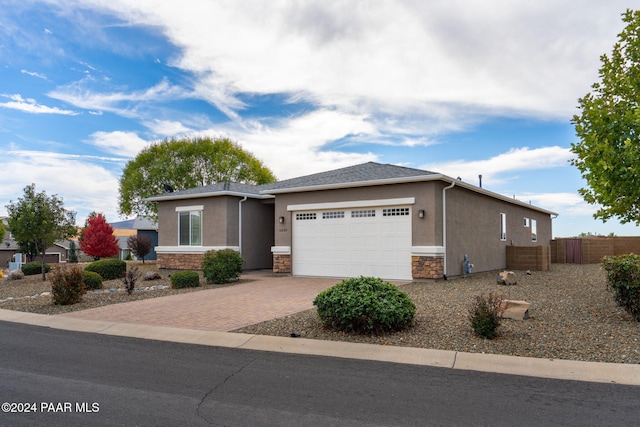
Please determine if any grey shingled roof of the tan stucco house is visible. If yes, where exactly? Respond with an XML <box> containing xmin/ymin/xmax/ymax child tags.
<box><xmin>147</xmin><ymin>162</ymin><xmax>558</xmax><ymax>215</ymax></box>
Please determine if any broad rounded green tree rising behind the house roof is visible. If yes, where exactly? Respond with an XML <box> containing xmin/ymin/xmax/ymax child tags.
<box><xmin>119</xmin><ymin>138</ymin><xmax>275</xmax><ymax>218</ymax></box>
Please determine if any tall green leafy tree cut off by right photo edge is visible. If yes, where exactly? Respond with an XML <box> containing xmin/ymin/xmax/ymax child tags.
<box><xmin>571</xmin><ymin>10</ymin><xmax>640</xmax><ymax>225</ymax></box>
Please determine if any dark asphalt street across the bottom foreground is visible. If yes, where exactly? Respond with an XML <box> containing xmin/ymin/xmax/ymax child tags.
<box><xmin>0</xmin><ymin>322</ymin><xmax>640</xmax><ymax>426</ymax></box>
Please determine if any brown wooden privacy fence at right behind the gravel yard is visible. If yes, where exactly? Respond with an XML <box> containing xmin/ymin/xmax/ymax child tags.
<box><xmin>551</xmin><ymin>236</ymin><xmax>640</xmax><ymax>264</ymax></box>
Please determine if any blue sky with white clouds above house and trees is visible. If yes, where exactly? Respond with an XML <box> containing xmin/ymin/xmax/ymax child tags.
<box><xmin>0</xmin><ymin>0</ymin><xmax>640</xmax><ymax>237</ymax></box>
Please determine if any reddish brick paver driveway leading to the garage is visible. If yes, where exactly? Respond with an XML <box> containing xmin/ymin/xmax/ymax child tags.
<box><xmin>59</xmin><ymin>271</ymin><xmax>340</xmax><ymax>332</ymax></box>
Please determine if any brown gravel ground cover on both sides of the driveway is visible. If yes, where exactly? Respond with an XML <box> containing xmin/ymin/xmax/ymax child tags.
<box><xmin>0</xmin><ymin>263</ymin><xmax>640</xmax><ymax>364</ymax></box>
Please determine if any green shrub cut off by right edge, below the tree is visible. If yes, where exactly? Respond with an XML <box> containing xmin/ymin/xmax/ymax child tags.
<box><xmin>601</xmin><ymin>254</ymin><xmax>640</xmax><ymax>321</ymax></box>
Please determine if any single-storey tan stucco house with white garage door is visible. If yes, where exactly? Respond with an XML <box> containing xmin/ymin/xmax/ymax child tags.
<box><xmin>148</xmin><ymin>162</ymin><xmax>557</xmax><ymax>280</ymax></box>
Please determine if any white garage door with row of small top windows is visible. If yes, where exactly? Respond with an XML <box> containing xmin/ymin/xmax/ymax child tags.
<box><xmin>292</xmin><ymin>206</ymin><xmax>411</xmax><ymax>280</ymax></box>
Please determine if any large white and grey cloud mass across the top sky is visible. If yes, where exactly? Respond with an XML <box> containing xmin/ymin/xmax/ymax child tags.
<box><xmin>69</xmin><ymin>0</ymin><xmax>626</xmax><ymax>123</ymax></box>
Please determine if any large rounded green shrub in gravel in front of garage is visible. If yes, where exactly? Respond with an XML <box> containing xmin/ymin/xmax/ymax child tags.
<box><xmin>313</xmin><ymin>277</ymin><xmax>416</xmax><ymax>333</ymax></box>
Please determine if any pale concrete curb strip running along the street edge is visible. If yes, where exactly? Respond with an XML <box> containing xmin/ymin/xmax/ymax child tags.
<box><xmin>0</xmin><ymin>309</ymin><xmax>640</xmax><ymax>386</ymax></box>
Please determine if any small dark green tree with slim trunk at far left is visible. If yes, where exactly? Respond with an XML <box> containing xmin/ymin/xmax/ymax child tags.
<box><xmin>7</xmin><ymin>184</ymin><xmax>76</xmax><ymax>281</ymax></box>
